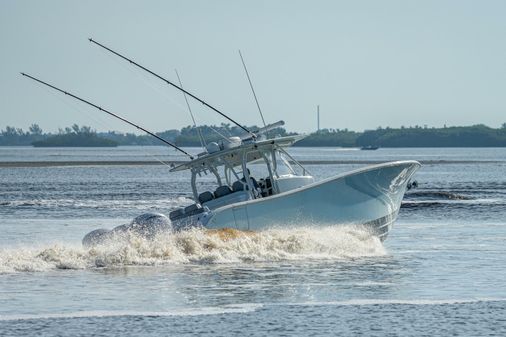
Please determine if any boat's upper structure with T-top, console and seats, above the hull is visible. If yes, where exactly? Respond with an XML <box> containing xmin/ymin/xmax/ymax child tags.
<box><xmin>169</xmin><ymin>136</ymin><xmax>314</xmax><ymax>226</ymax></box>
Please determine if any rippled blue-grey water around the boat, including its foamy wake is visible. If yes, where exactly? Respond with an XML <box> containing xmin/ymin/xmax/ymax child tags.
<box><xmin>0</xmin><ymin>147</ymin><xmax>506</xmax><ymax>337</ymax></box>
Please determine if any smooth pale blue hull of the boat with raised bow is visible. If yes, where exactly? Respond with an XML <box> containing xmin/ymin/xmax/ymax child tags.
<box><xmin>201</xmin><ymin>161</ymin><xmax>420</xmax><ymax>240</ymax></box>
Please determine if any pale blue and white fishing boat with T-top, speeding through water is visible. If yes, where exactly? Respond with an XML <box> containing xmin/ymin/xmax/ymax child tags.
<box><xmin>169</xmin><ymin>123</ymin><xmax>420</xmax><ymax>240</ymax></box>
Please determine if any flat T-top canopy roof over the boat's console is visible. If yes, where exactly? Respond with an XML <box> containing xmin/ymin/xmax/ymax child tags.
<box><xmin>170</xmin><ymin>135</ymin><xmax>305</xmax><ymax>173</ymax></box>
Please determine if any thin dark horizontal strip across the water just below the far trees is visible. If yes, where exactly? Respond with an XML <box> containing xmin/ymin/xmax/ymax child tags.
<box><xmin>0</xmin><ymin>160</ymin><xmax>506</xmax><ymax>168</ymax></box>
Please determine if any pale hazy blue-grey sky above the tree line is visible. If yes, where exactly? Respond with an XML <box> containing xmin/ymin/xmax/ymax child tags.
<box><xmin>0</xmin><ymin>0</ymin><xmax>506</xmax><ymax>132</ymax></box>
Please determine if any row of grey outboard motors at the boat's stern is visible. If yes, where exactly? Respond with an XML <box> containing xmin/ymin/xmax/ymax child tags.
<box><xmin>82</xmin><ymin>213</ymin><xmax>172</xmax><ymax>247</ymax></box>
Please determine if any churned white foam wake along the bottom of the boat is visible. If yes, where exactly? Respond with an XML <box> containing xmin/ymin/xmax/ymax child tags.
<box><xmin>0</xmin><ymin>226</ymin><xmax>386</xmax><ymax>273</ymax></box>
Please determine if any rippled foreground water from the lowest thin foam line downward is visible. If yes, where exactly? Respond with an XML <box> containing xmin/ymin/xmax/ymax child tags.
<box><xmin>4</xmin><ymin>300</ymin><xmax>505</xmax><ymax>337</ymax></box>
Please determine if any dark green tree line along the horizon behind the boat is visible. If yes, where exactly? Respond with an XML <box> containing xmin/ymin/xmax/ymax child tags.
<box><xmin>0</xmin><ymin>123</ymin><xmax>506</xmax><ymax>147</ymax></box>
